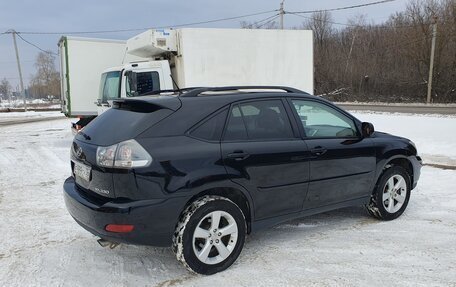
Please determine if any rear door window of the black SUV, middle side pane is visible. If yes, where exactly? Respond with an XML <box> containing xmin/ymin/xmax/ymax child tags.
<box><xmin>225</xmin><ymin>100</ymin><xmax>293</xmax><ymax>140</ymax></box>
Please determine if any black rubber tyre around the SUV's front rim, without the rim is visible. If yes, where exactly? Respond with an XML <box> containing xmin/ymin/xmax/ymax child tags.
<box><xmin>366</xmin><ymin>165</ymin><xmax>411</xmax><ymax>220</ymax></box>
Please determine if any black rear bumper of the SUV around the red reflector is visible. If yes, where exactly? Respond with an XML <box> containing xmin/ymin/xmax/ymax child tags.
<box><xmin>63</xmin><ymin>177</ymin><xmax>187</xmax><ymax>246</ymax></box>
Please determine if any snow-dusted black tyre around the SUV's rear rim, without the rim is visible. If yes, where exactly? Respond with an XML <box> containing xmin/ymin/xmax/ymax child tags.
<box><xmin>173</xmin><ymin>196</ymin><xmax>246</xmax><ymax>275</ymax></box>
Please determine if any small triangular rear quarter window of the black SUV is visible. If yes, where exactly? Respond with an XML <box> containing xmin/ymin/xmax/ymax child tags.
<box><xmin>190</xmin><ymin>109</ymin><xmax>228</xmax><ymax>141</ymax></box>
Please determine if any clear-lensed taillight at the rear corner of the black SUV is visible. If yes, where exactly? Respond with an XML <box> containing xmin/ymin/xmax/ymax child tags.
<box><xmin>97</xmin><ymin>140</ymin><xmax>152</xmax><ymax>169</ymax></box>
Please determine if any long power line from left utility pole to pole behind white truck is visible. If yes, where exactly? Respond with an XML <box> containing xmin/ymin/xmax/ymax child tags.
<box><xmin>2</xmin><ymin>9</ymin><xmax>278</xmax><ymax>35</ymax></box>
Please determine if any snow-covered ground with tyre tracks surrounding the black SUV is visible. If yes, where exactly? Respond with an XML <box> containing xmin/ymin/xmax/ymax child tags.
<box><xmin>0</xmin><ymin>113</ymin><xmax>456</xmax><ymax>286</ymax></box>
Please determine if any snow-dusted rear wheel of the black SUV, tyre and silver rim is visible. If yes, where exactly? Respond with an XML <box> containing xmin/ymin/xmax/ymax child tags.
<box><xmin>173</xmin><ymin>196</ymin><xmax>246</xmax><ymax>275</ymax></box>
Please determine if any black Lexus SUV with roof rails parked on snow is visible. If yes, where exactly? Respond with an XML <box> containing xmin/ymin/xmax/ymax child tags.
<box><xmin>64</xmin><ymin>87</ymin><xmax>421</xmax><ymax>274</ymax></box>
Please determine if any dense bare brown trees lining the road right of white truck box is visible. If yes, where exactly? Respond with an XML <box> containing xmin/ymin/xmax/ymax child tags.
<box><xmin>241</xmin><ymin>0</ymin><xmax>456</xmax><ymax>103</ymax></box>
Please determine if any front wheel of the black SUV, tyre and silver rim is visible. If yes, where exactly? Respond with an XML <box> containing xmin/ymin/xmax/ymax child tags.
<box><xmin>366</xmin><ymin>165</ymin><xmax>411</xmax><ymax>220</ymax></box>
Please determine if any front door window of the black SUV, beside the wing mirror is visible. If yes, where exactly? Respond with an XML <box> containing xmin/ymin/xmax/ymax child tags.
<box><xmin>292</xmin><ymin>100</ymin><xmax>358</xmax><ymax>138</ymax></box>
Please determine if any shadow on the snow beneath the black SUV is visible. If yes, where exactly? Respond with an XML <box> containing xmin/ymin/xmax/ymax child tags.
<box><xmin>100</xmin><ymin>207</ymin><xmax>379</xmax><ymax>281</ymax></box>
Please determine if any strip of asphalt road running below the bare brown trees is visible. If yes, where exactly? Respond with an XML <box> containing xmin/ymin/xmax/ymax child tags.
<box><xmin>336</xmin><ymin>103</ymin><xmax>456</xmax><ymax>115</ymax></box>
